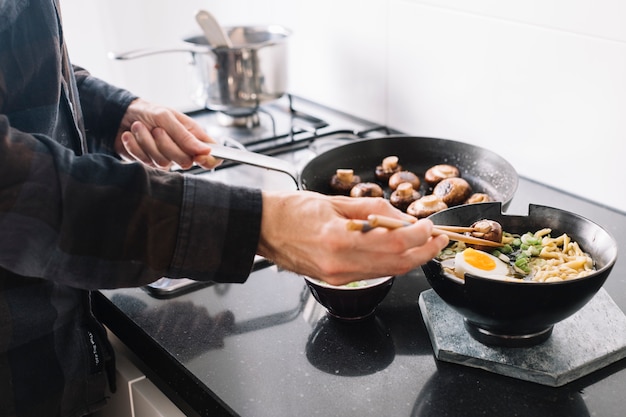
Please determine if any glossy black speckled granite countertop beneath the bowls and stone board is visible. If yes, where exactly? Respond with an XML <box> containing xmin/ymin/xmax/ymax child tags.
<box><xmin>94</xmin><ymin>178</ymin><xmax>626</xmax><ymax>417</ymax></box>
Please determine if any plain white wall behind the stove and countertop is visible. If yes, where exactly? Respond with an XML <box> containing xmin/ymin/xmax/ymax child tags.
<box><xmin>62</xmin><ymin>0</ymin><xmax>626</xmax><ymax>211</ymax></box>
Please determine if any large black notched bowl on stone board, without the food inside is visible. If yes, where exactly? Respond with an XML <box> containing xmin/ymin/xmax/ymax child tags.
<box><xmin>422</xmin><ymin>203</ymin><xmax>617</xmax><ymax>347</ymax></box>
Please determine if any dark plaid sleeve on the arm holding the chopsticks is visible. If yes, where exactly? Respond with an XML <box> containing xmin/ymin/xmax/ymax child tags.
<box><xmin>0</xmin><ymin>115</ymin><xmax>262</xmax><ymax>289</ymax></box>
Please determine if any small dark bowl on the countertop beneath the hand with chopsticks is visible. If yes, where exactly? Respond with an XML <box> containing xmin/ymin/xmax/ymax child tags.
<box><xmin>304</xmin><ymin>276</ymin><xmax>394</xmax><ymax>320</ymax></box>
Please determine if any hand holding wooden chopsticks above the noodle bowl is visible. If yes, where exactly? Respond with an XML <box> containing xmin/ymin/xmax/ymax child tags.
<box><xmin>258</xmin><ymin>191</ymin><xmax>448</xmax><ymax>285</ymax></box>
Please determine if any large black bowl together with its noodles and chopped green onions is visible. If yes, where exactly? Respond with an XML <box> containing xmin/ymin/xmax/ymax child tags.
<box><xmin>422</xmin><ymin>202</ymin><xmax>618</xmax><ymax>348</ymax></box>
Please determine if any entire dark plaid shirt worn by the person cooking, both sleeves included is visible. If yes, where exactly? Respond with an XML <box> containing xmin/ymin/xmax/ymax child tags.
<box><xmin>0</xmin><ymin>0</ymin><xmax>261</xmax><ymax>417</ymax></box>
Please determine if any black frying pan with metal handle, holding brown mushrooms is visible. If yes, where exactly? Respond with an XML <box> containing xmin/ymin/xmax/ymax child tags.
<box><xmin>206</xmin><ymin>136</ymin><xmax>518</xmax><ymax>207</ymax></box>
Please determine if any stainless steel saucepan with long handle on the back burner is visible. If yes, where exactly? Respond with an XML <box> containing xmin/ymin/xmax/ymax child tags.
<box><xmin>111</xmin><ymin>25</ymin><xmax>291</xmax><ymax>115</ymax></box>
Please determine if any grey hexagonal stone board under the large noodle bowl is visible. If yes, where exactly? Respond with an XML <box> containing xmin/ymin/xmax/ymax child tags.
<box><xmin>419</xmin><ymin>289</ymin><xmax>626</xmax><ymax>387</ymax></box>
